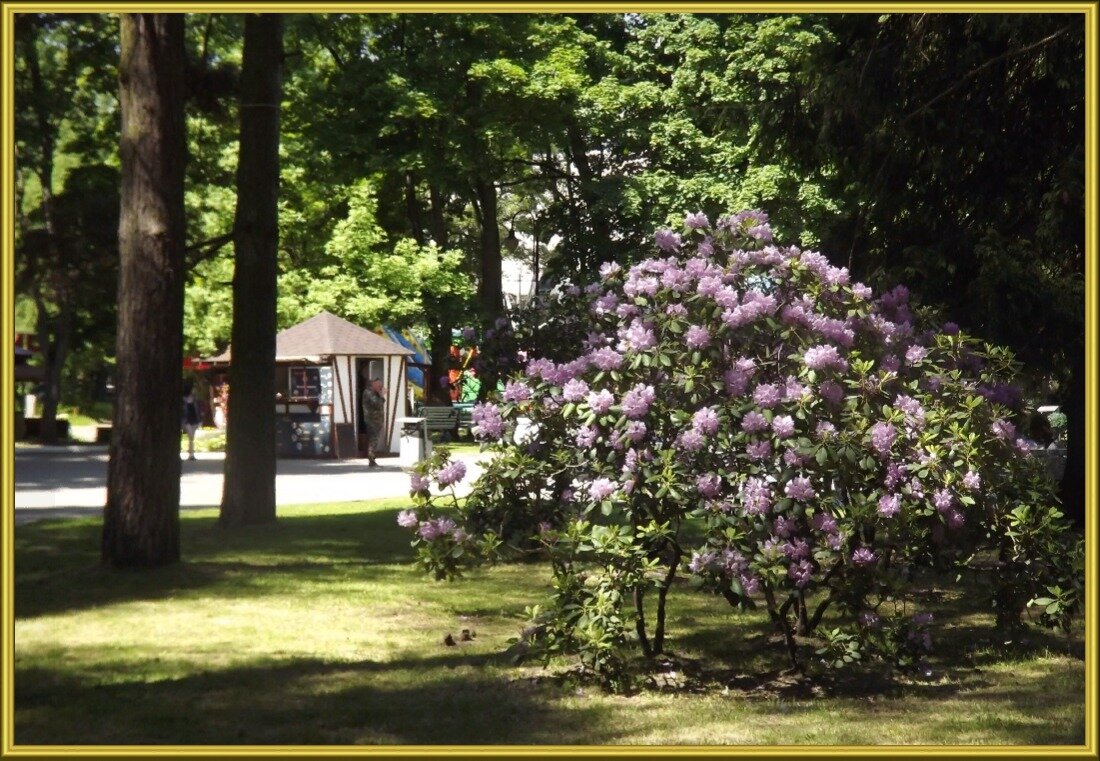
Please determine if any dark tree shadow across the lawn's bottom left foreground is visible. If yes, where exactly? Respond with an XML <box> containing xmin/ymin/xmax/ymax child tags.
<box><xmin>15</xmin><ymin>654</ymin><xmax>616</xmax><ymax>745</ymax></box>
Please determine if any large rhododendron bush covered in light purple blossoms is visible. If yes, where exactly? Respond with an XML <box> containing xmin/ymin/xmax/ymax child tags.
<box><xmin>402</xmin><ymin>212</ymin><xmax>1081</xmax><ymax>680</ymax></box>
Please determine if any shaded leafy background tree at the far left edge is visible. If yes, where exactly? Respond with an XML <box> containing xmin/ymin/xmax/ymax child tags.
<box><xmin>15</xmin><ymin>13</ymin><xmax>118</xmax><ymax>442</ymax></box>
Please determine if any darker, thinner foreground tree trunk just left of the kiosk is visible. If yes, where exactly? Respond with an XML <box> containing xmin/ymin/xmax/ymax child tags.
<box><xmin>219</xmin><ymin>13</ymin><xmax>283</xmax><ymax>526</ymax></box>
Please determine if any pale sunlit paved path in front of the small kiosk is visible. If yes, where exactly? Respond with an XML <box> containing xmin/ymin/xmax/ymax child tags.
<box><xmin>15</xmin><ymin>446</ymin><xmax>485</xmax><ymax>525</ymax></box>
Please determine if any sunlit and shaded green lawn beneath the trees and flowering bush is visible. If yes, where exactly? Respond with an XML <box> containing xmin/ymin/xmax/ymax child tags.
<box><xmin>14</xmin><ymin>500</ymin><xmax>1084</xmax><ymax>746</ymax></box>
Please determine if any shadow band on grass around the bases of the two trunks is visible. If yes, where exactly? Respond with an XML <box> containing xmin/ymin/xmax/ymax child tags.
<box><xmin>14</xmin><ymin>509</ymin><xmax>414</xmax><ymax>618</ymax></box>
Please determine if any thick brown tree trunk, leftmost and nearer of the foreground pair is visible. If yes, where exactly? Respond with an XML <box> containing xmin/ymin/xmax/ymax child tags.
<box><xmin>102</xmin><ymin>13</ymin><xmax>187</xmax><ymax>566</ymax></box>
